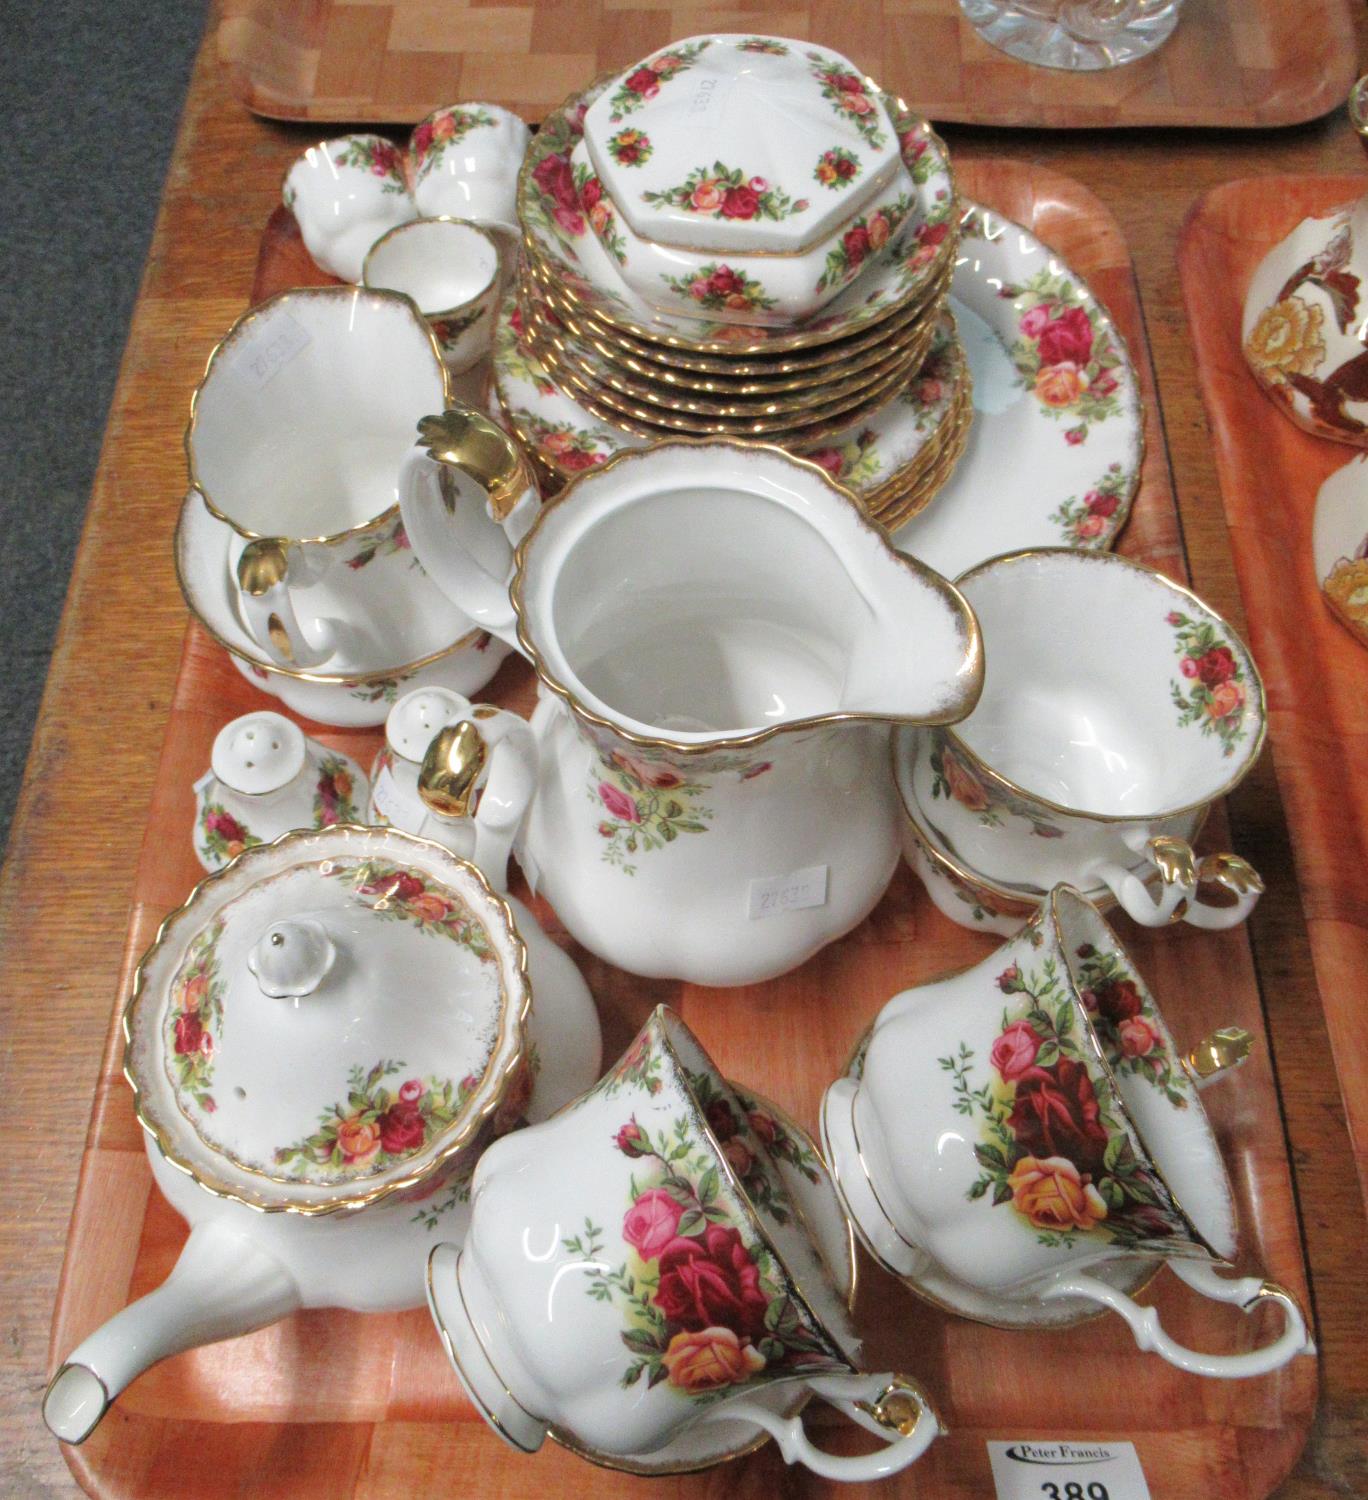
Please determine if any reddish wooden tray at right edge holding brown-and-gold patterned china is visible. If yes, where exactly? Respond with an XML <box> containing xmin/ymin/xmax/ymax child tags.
<box><xmin>1179</xmin><ymin>177</ymin><xmax>1368</xmax><ymax>1196</ymax></box>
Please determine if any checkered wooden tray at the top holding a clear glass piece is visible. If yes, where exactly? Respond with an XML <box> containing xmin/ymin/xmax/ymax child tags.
<box><xmin>219</xmin><ymin>0</ymin><xmax>1356</xmax><ymax>128</ymax></box>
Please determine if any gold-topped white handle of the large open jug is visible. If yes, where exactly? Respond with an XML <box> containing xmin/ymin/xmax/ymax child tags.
<box><xmin>399</xmin><ymin>407</ymin><xmax>540</xmax><ymax>651</ymax></box>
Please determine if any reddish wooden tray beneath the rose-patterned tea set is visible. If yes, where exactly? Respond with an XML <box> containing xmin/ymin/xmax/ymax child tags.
<box><xmin>51</xmin><ymin>161</ymin><xmax>1317</xmax><ymax>1500</ymax></box>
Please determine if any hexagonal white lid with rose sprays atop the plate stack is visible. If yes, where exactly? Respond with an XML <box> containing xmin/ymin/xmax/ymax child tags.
<box><xmin>584</xmin><ymin>35</ymin><xmax>899</xmax><ymax>255</ymax></box>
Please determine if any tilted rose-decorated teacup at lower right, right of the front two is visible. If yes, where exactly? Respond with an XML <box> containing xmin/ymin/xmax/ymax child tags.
<box><xmin>822</xmin><ymin>885</ymin><xmax>1313</xmax><ymax>1379</ymax></box>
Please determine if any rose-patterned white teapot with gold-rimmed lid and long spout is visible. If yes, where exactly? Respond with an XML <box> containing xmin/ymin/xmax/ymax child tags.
<box><xmin>44</xmin><ymin>825</ymin><xmax>599</xmax><ymax>1443</ymax></box>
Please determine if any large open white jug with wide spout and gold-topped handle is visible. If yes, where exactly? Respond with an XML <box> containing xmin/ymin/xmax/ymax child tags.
<box><xmin>399</xmin><ymin>410</ymin><xmax>983</xmax><ymax>986</ymax></box>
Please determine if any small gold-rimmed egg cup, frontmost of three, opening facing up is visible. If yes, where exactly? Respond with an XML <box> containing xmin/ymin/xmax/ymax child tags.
<box><xmin>362</xmin><ymin>219</ymin><xmax>500</xmax><ymax>375</ymax></box>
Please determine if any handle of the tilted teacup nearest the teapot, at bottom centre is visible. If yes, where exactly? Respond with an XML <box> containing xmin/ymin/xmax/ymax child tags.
<box><xmin>702</xmin><ymin>1374</ymin><xmax>945</xmax><ymax>1484</ymax></box>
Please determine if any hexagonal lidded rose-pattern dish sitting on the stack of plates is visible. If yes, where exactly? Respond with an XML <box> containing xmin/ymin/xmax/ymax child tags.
<box><xmin>572</xmin><ymin>35</ymin><xmax>921</xmax><ymax>323</ymax></box>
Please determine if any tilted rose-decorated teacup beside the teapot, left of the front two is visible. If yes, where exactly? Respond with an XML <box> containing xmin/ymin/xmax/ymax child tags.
<box><xmin>429</xmin><ymin>1007</ymin><xmax>939</xmax><ymax>1481</ymax></box>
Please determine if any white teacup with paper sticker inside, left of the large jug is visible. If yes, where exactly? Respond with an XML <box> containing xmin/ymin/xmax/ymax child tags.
<box><xmin>185</xmin><ymin>287</ymin><xmax>486</xmax><ymax>671</ymax></box>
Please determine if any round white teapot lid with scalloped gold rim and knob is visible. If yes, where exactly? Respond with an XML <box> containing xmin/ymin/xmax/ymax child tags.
<box><xmin>125</xmin><ymin>827</ymin><xmax>531</xmax><ymax>1214</ymax></box>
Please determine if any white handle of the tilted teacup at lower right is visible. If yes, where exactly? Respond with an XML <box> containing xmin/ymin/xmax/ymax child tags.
<box><xmin>1041</xmin><ymin>1260</ymin><xmax>1316</xmax><ymax>1380</ymax></box>
